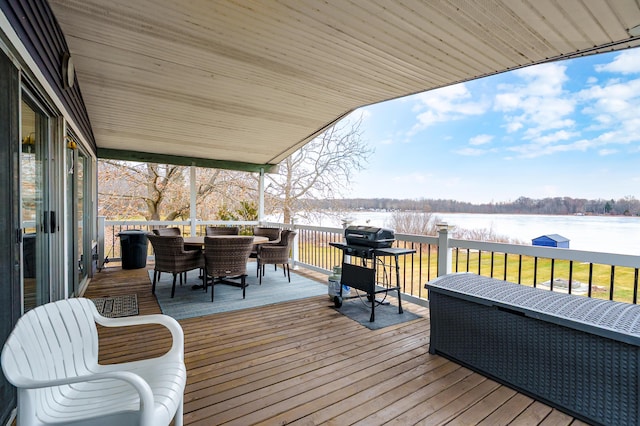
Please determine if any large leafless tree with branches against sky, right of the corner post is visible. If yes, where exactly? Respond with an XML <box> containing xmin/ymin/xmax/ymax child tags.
<box><xmin>265</xmin><ymin>117</ymin><xmax>374</xmax><ymax>223</ymax></box>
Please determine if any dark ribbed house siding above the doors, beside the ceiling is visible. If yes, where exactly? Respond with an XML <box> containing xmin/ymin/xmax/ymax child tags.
<box><xmin>0</xmin><ymin>0</ymin><xmax>97</xmax><ymax>153</ymax></box>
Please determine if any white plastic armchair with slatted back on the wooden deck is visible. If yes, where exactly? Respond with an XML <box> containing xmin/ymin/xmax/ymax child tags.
<box><xmin>1</xmin><ymin>298</ymin><xmax>187</xmax><ymax>426</ymax></box>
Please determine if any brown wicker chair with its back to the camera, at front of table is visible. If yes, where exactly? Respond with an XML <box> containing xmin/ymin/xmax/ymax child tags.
<box><xmin>202</xmin><ymin>235</ymin><xmax>253</xmax><ymax>302</ymax></box>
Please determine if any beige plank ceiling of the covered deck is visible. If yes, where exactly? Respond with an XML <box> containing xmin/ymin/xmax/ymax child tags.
<box><xmin>50</xmin><ymin>0</ymin><xmax>640</xmax><ymax>171</ymax></box>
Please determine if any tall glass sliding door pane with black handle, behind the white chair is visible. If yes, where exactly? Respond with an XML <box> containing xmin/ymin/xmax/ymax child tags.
<box><xmin>20</xmin><ymin>100</ymin><xmax>54</xmax><ymax>312</ymax></box>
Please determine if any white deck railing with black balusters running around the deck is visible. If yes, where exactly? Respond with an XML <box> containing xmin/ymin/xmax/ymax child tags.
<box><xmin>98</xmin><ymin>220</ymin><xmax>640</xmax><ymax>304</ymax></box>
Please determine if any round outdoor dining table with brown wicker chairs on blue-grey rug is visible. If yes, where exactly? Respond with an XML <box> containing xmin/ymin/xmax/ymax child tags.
<box><xmin>147</xmin><ymin>226</ymin><xmax>296</xmax><ymax>302</ymax></box>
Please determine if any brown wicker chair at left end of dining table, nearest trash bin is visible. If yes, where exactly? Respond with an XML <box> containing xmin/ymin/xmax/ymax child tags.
<box><xmin>148</xmin><ymin>234</ymin><xmax>204</xmax><ymax>298</ymax></box>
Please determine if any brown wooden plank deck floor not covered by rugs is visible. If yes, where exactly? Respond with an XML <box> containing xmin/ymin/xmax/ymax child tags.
<box><xmin>85</xmin><ymin>266</ymin><xmax>584</xmax><ymax>426</ymax></box>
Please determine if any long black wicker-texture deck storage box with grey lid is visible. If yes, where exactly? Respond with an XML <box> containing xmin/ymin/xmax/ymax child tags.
<box><xmin>427</xmin><ymin>273</ymin><xmax>640</xmax><ymax>425</ymax></box>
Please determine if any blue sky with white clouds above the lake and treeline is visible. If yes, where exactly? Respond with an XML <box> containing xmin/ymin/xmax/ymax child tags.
<box><xmin>345</xmin><ymin>48</ymin><xmax>640</xmax><ymax>203</ymax></box>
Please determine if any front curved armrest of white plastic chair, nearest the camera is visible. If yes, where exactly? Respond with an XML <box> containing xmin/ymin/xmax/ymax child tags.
<box><xmin>13</xmin><ymin>371</ymin><xmax>154</xmax><ymax>425</ymax></box>
